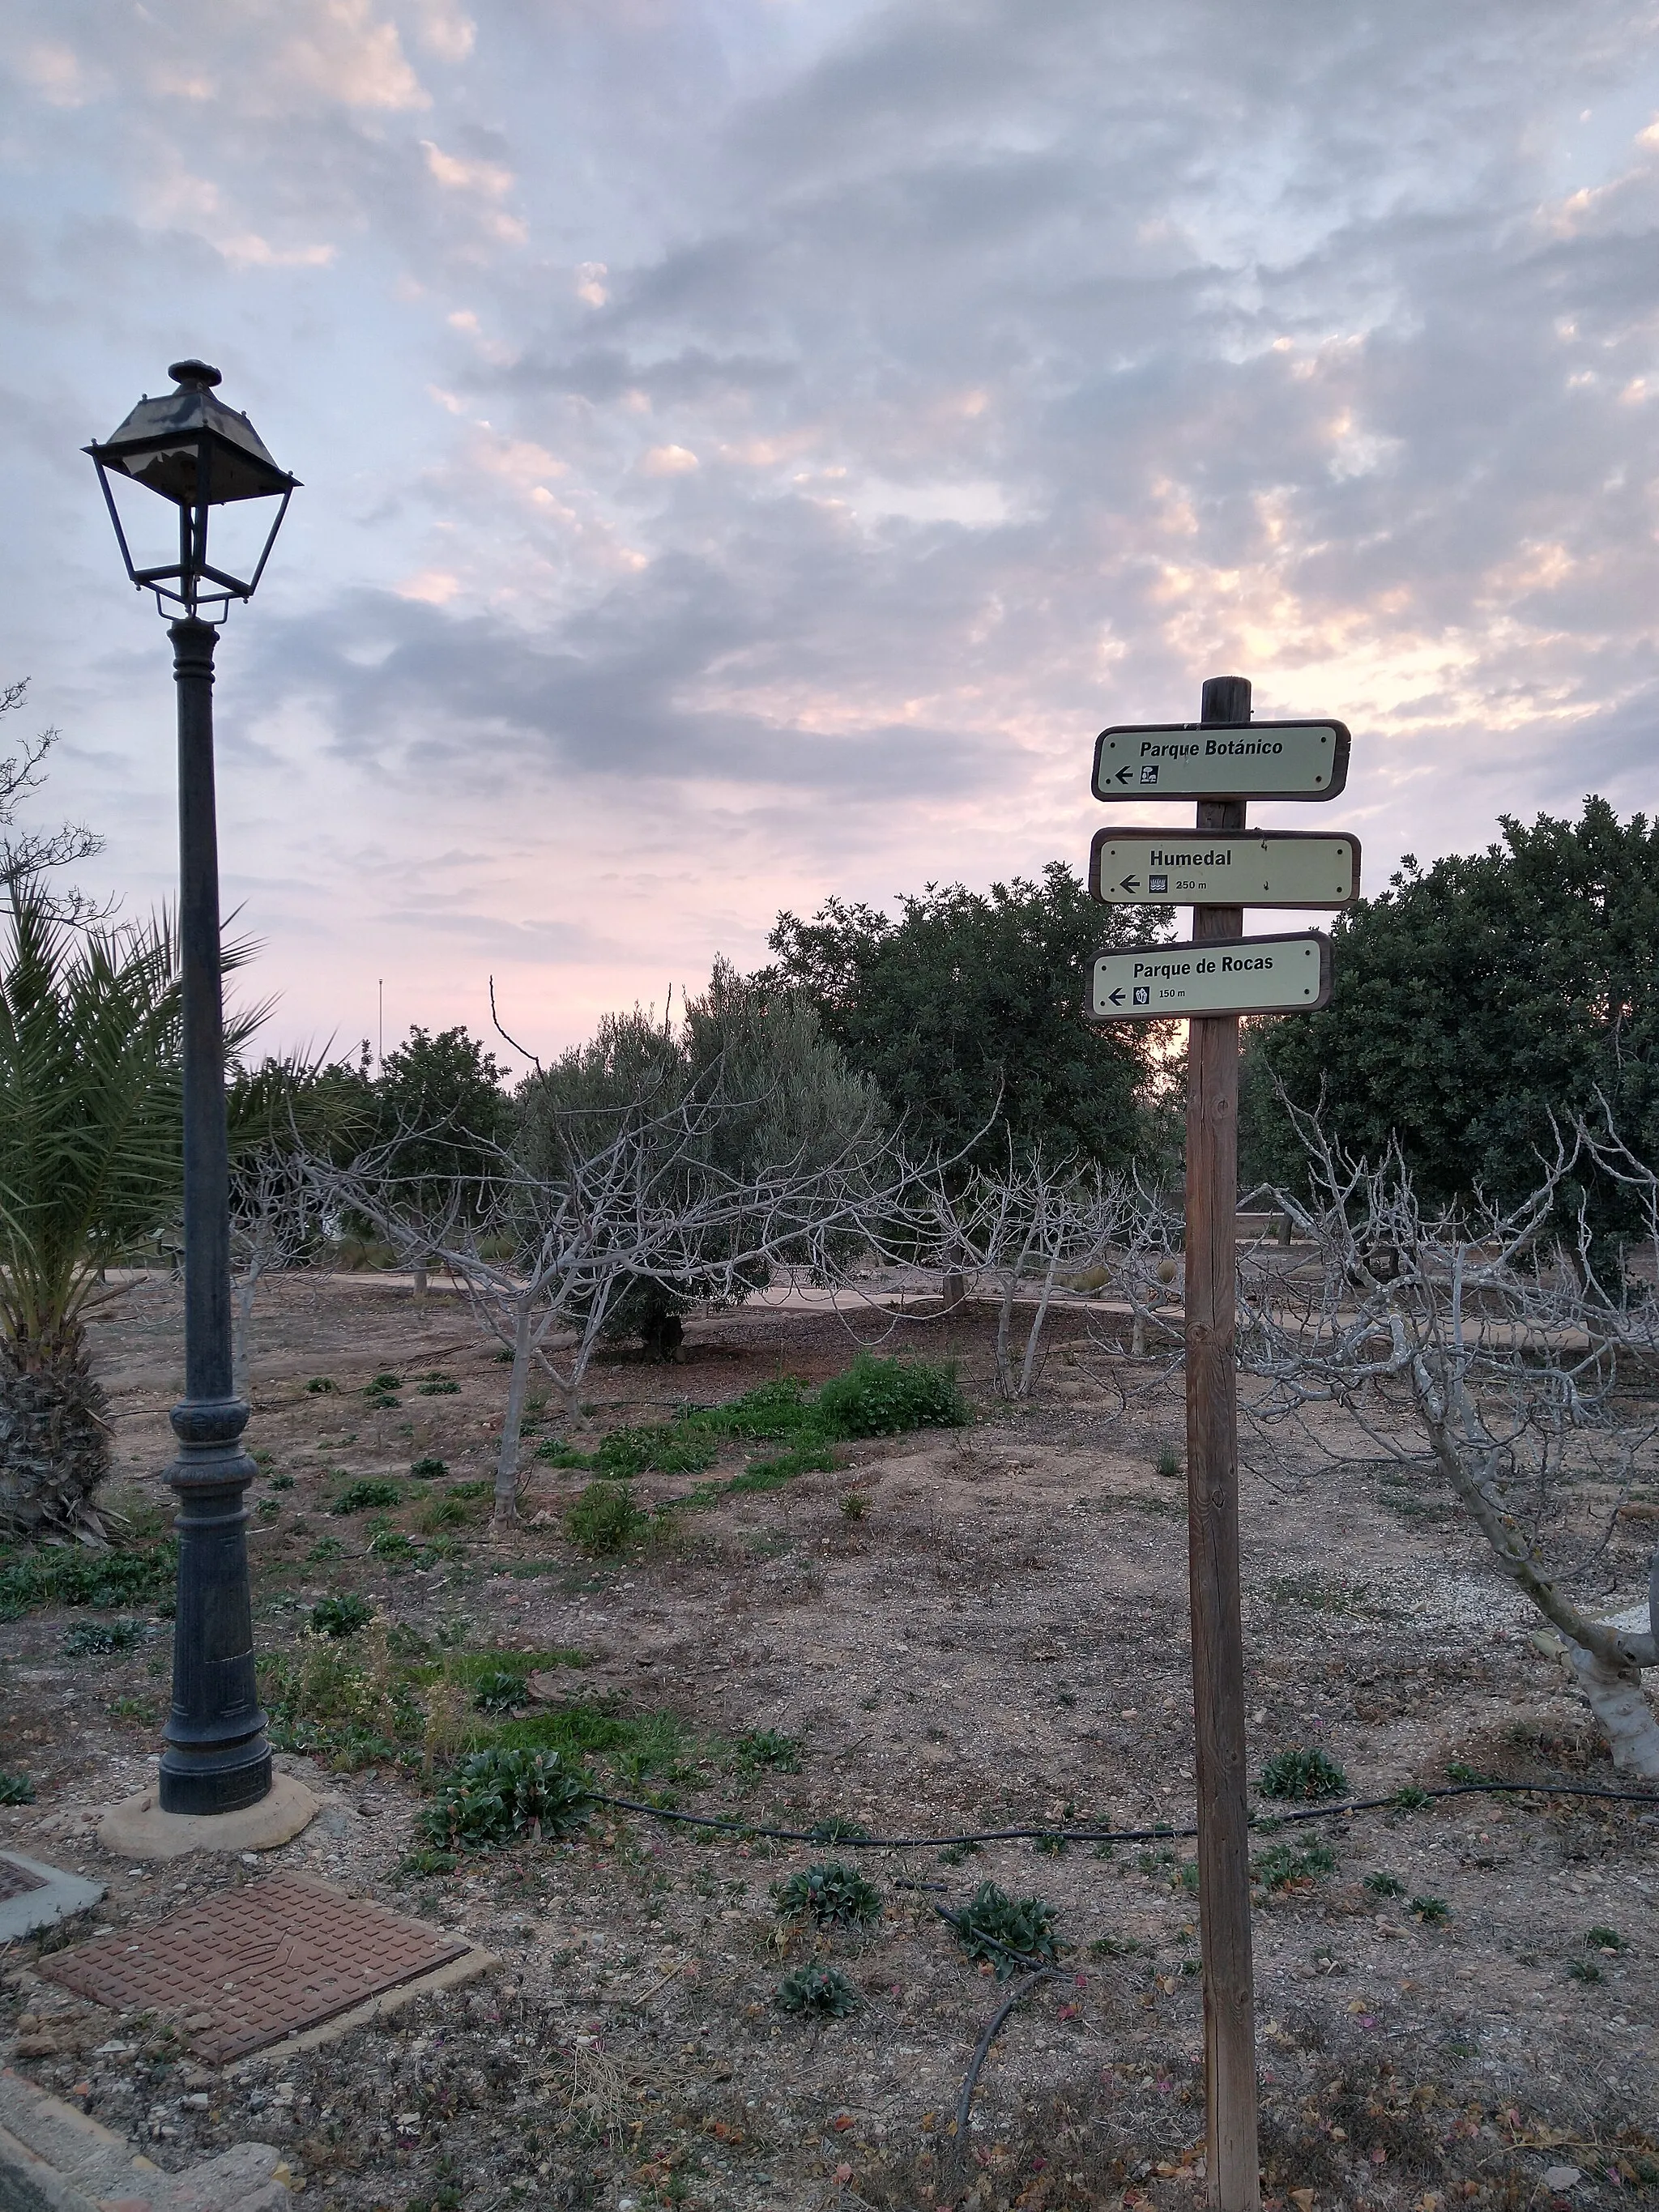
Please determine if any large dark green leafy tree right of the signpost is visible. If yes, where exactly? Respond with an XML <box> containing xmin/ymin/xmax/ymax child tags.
<box><xmin>1241</xmin><ymin>799</ymin><xmax>1659</xmax><ymax>1205</ymax></box>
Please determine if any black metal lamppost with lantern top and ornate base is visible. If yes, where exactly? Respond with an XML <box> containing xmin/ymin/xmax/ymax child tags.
<box><xmin>86</xmin><ymin>360</ymin><xmax>296</xmax><ymax>1813</ymax></box>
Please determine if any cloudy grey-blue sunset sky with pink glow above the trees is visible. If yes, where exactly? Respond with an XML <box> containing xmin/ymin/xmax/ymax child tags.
<box><xmin>0</xmin><ymin>0</ymin><xmax>1659</xmax><ymax>1057</ymax></box>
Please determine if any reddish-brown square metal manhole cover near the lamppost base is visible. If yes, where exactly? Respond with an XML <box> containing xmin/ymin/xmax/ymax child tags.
<box><xmin>36</xmin><ymin>1873</ymin><xmax>471</xmax><ymax>2066</ymax></box>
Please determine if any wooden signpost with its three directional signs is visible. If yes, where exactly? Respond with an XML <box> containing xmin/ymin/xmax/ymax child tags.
<box><xmin>1088</xmin><ymin>677</ymin><xmax>1358</xmax><ymax>2212</ymax></box>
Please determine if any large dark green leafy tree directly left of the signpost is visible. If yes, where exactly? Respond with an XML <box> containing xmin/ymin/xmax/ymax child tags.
<box><xmin>761</xmin><ymin>860</ymin><xmax>1168</xmax><ymax>1170</ymax></box>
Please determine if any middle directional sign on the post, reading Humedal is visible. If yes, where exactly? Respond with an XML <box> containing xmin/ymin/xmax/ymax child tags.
<box><xmin>1088</xmin><ymin>829</ymin><xmax>1360</xmax><ymax>907</ymax></box>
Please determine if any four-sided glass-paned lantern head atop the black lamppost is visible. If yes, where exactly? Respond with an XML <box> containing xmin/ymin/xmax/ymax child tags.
<box><xmin>84</xmin><ymin>360</ymin><xmax>299</xmax><ymax>621</ymax></box>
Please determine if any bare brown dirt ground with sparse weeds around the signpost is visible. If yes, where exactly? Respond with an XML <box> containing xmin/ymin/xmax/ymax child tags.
<box><xmin>0</xmin><ymin>1279</ymin><xmax>1659</xmax><ymax>2212</ymax></box>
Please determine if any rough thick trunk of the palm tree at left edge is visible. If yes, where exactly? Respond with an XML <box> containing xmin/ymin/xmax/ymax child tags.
<box><xmin>0</xmin><ymin>1320</ymin><xmax>111</xmax><ymax>1537</ymax></box>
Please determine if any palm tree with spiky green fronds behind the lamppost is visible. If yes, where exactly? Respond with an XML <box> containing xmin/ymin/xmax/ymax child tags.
<box><xmin>0</xmin><ymin>874</ymin><xmax>263</xmax><ymax>1537</ymax></box>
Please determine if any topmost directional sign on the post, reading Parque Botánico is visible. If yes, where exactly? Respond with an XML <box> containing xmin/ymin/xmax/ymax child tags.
<box><xmin>1095</xmin><ymin>721</ymin><xmax>1350</xmax><ymax>799</ymax></box>
